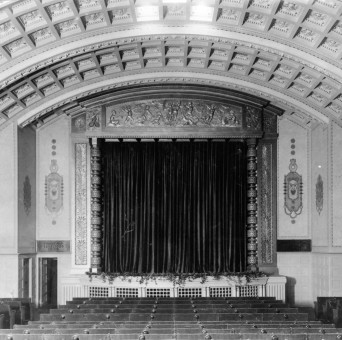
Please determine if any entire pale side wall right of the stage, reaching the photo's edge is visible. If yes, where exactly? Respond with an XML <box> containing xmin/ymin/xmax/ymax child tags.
<box><xmin>278</xmin><ymin>117</ymin><xmax>342</xmax><ymax>306</ymax></box>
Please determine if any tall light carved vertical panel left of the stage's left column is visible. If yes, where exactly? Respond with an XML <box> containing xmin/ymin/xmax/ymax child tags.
<box><xmin>75</xmin><ymin>143</ymin><xmax>87</xmax><ymax>265</ymax></box>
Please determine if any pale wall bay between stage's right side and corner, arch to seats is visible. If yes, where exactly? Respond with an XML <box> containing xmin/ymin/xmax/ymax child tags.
<box><xmin>277</xmin><ymin>117</ymin><xmax>313</xmax><ymax>306</ymax></box>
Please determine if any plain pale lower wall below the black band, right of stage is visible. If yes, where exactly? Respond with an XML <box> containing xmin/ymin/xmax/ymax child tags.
<box><xmin>278</xmin><ymin>252</ymin><xmax>313</xmax><ymax>307</ymax></box>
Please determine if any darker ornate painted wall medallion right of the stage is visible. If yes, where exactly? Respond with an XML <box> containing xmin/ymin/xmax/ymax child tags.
<box><xmin>284</xmin><ymin>158</ymin><xmax>303</xmax><ymax>219</ymax></box>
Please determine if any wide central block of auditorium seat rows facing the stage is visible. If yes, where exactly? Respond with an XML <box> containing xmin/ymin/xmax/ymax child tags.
<box><xmin>0</xmin><ymin>297</ymin><xmax>342</xmax><ymax>340</ymax></box>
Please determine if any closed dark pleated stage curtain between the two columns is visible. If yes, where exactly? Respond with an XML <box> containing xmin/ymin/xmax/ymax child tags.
<box><xmin>103</xmin><ymin>141</ymin><xmax>247</xmax><ymax>274</ymax></box>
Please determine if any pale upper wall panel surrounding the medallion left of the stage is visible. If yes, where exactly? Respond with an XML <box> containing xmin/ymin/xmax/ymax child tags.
<box><xmin>37</xmin><ymin>116</ymin><xmax>70</xmax><ymax>240</ymax></box>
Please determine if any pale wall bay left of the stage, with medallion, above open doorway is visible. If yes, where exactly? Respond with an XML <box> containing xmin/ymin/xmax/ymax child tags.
<box><xmin>36</xmin><ymin>116</ymin><xmax>73</xmax><ymax>299</ymax></box>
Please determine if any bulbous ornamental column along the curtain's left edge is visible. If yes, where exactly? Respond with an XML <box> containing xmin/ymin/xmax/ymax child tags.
<box><xmin>90</xmin><ymin>138</ymin><xmax>103</xmax><ymax>273</ymax></box>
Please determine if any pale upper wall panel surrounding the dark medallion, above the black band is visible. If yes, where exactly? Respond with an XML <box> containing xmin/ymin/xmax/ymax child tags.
<box><xmin>278</xmin><ymin>117</ymin><xmax>311</xmax><ymax>239</ymax></box>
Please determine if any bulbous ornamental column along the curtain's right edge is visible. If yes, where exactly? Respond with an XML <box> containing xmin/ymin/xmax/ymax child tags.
<box><xmin>247</xmin><ymin>138</ymin><xmax>258</xmax><ymax>271</ymax></box>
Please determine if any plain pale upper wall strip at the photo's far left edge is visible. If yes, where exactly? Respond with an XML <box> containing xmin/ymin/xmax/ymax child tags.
<box><xmin>0</xmin><ymin>124</ymin><xmax>18</xmax><ymax>252</ymax></box>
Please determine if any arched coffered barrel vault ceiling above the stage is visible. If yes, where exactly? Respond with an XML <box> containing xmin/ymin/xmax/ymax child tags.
<box><xmin>0</xmin><ymin>0</ymin><xmax>342</xmax><ymax>129</ymax></box>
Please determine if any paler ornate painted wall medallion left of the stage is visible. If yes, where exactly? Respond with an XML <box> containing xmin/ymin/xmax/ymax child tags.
<box><xmin>45</xmin><ymin>159</ymin><xmax>63</xmax><ymax>224</ymax></box>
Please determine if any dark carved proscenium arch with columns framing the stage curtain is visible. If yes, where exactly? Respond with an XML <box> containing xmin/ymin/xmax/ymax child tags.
<box><xmin>72</xmin><ymin>84</ymin><xmax>283</xmax><ymax>274</ymax></box>
